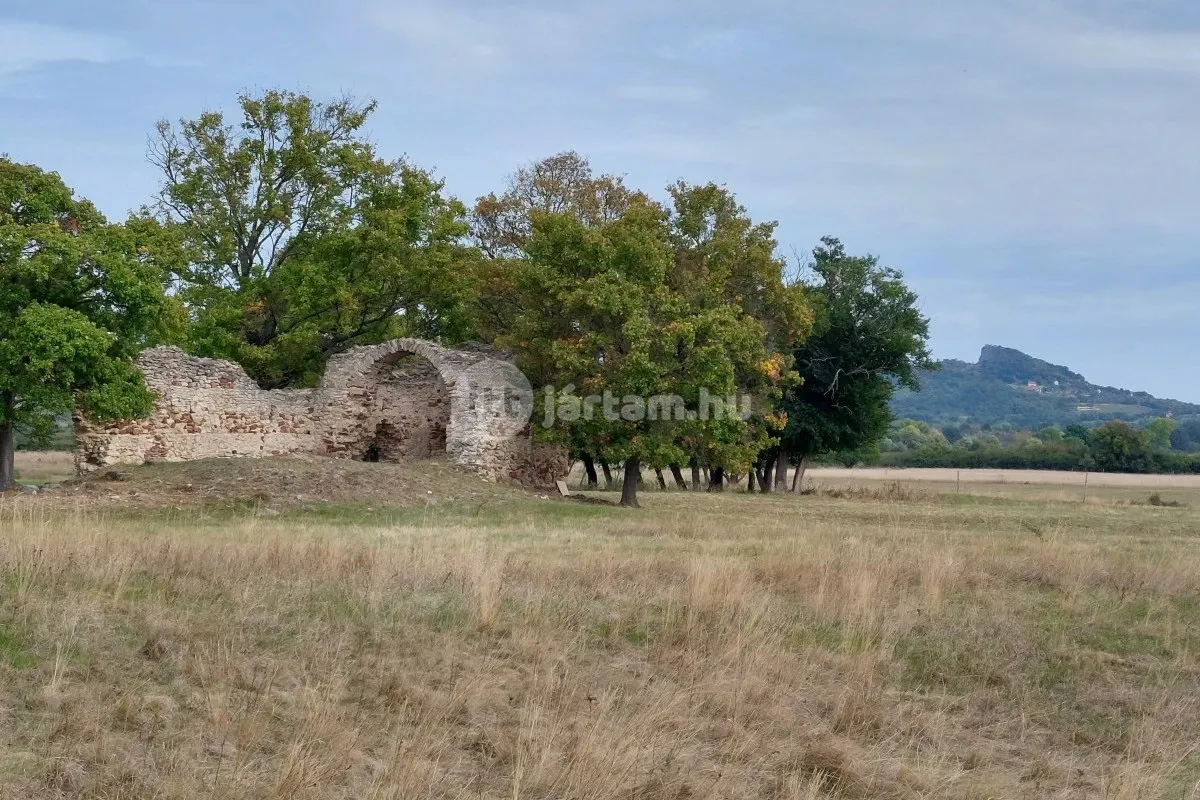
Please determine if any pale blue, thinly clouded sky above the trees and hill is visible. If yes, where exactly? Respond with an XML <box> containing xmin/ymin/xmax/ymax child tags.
<box><xmin>0</xmin><ymin>0</ymin><xmax>1200</xmax><ymax>402</ymax></box>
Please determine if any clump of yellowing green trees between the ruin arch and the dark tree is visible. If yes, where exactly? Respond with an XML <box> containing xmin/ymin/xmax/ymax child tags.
<box><xmin>473</xmin><ymin>152</ymin><xmax>811</xmax><ymax>504</ymax></box>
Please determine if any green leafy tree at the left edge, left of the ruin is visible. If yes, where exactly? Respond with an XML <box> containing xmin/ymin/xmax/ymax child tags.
<box><xmin>0</xmin><ymin>158</ymin><xmax>170</xmax><ymax>489</ymax></box>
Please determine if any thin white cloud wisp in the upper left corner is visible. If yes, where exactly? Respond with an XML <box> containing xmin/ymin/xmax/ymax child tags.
<box><xmin>0</xmin><ymin>19</ymin><xmax>131</xmax><ymax>82</ymax></box>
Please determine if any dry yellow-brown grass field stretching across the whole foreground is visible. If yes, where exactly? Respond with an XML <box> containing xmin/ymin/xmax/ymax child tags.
<box><xmin>0</xmin><ymin>462</ymin><xmax>1200</xmax><ymax>800</ymax></box>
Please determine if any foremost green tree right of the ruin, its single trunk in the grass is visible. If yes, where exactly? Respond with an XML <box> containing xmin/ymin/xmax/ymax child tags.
<box><xmin>498</xmin><ymin>198</ymin><xmax>762</xmax><ymax>506</ymax></box>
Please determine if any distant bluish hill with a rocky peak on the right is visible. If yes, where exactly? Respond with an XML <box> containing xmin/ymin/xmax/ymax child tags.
<box><xmin>892</xmin><ymin>344</ymin><xmax>1200</xmax><ymax>428</ymax></box>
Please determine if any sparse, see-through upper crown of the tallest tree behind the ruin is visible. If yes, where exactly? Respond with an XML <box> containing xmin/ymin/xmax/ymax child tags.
<box><xmin>150</xmin><ymin>91</ymin><xmax>390</xmax><ymax>289</ymax></box>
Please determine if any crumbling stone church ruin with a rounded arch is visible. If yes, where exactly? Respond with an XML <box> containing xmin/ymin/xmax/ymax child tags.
<box><xmin>76</xmin><ymin>339</ymin><xmax>568</xmax><ymax>486</ymax></box>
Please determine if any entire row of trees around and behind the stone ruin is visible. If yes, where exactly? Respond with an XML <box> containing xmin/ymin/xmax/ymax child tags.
<box><xmin>0</xmin><ymin>91</ymin><xmax>935</xmax><ymax>505</ymax></box>
